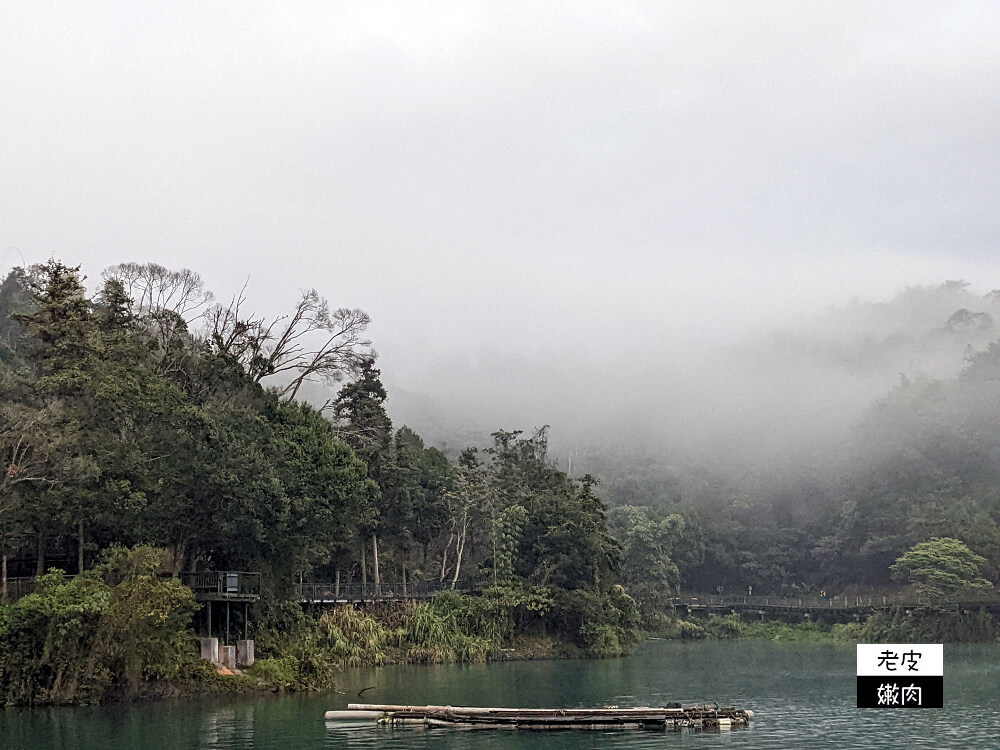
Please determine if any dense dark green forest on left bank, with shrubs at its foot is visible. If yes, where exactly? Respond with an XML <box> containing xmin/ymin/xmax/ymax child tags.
<box><xmin>0</xmin><ymin>260</ymin><xmax>636</xmax><ymax>702</ymax></box>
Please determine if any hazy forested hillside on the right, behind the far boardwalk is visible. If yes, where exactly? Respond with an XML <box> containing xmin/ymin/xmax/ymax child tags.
<box><xmin>556</xmin><ymin>282</ymin><xmax>1000</xmax><ymax>640</ymax></box>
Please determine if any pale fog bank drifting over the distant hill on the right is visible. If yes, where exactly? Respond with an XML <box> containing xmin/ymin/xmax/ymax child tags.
<box><xmin>384</xmin><ymin>281</ymin><xmax>1000</xmax><ymax>470</ymax></box>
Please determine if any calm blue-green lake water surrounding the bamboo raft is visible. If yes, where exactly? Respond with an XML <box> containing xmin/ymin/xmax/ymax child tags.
<box><xmin>0</xmin><ymin>641</ymin><xmax>1000</xmax><ymax>750</ymax></box>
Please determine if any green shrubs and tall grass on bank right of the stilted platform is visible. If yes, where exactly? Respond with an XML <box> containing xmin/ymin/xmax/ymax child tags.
<box><xmin>259</xmin><ymin>586</ymin><xmax>638</xmax><ymax>689</ymax></box>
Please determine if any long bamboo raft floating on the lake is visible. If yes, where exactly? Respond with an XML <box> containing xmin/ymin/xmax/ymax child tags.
<box><xmin>326</xmin><ymin>703</ymin><xmax>753</xmax><ymax>730</ymax></box>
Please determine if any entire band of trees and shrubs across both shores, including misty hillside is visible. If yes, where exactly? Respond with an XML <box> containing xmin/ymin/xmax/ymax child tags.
<box><xmin>0</xmin><ymin>260</ymin><xmax>1000</xmax><ymax>705</ymax></box>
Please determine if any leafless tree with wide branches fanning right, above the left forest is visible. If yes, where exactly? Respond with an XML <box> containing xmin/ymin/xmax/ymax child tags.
<box><xmin>208</xmin><ymin>289</ymin><xmax>374</xmax><ymax>406</ymax></box>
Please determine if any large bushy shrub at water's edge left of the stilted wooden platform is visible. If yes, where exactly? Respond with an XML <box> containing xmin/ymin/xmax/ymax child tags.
<box><xmin>0</xmin><ymin>547</ymin><xmax>197</xmax><ymax>705</ymax></box>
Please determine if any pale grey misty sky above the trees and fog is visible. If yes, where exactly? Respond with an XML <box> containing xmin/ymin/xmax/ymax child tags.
<box><xmin>0</xmin><ymin>0</ymin><xmax>1000</xmax><ymax>458</ymax></box>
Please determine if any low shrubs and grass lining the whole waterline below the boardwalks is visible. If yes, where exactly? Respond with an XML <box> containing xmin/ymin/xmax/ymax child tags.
<box><xmin>0</xmin><ymin>547</ymin><xmax>998</xmax><ymax>706</ymax></box>
